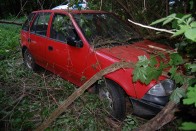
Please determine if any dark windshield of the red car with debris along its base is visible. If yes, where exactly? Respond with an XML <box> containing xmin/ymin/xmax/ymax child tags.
<box><xmin>74</xmin><ymin>13</ymin><xmax>139</xmax><ymax>47</ymax></box>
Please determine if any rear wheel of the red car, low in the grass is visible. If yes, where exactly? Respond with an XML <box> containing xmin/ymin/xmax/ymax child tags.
<box><xmin>23</xmin><ymin>49</ymin><xmax>37</xmax><ymax>71</ymax></box>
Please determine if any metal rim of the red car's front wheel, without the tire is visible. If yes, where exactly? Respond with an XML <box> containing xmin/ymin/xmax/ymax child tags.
<box><xmin>99</xmin><ymin>87</ymin><xmax>113</xmax><ymax>111</ymax></box>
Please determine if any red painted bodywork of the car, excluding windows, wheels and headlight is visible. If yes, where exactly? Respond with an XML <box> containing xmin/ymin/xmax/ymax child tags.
<box><xmin>21</xmin><ymin>10</ymin><xmax>172</xmax><ymax>99</ymax></box>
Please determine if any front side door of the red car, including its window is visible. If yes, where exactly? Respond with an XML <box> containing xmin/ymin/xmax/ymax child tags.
<box><xmin>46</xmin><ymin>14</ymin><xmax>89</xmax><ymax>85</ymax></box>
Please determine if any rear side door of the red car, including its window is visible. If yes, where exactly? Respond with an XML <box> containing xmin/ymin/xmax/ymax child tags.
<box><xmin>28</xmin><ymin>12</ymin><xmax>51</xmax><ymax>66</ymax></box>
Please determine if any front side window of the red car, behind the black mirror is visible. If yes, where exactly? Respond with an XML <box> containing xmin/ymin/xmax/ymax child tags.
<box><xmin>50</xmin><ymin>14</ymin><xmax>79</xmax><ymax>42</ymax></box>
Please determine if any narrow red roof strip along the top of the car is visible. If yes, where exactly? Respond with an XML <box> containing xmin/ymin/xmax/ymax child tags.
<box><xmin>33</xmin><ymin>9</ymin><xmax>108</xmax><ymax>14</ymax></box>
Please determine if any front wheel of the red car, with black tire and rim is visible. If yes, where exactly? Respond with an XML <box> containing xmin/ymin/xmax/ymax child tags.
<box><xmin>98</xmin><ymin>80</ymin><xmax>126</xmax><ymax>120</ymax></box>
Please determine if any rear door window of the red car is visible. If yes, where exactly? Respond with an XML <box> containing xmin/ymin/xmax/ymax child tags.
<box><xmin>31</xmin><ymin>13</ymin><xmax>50</xmax><ymax>36</ymax></box>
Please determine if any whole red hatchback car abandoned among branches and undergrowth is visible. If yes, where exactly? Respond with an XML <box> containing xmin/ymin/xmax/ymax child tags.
<box><xmin>21</xmin><ymin>10</ymin><xmax>174</xmax><ymax>120</ymax></box>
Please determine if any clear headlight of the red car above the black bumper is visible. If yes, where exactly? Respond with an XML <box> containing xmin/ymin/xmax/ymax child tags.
<box><xmin>147</xmin><ymin>79</ymin><xmax>175</xmax><ymax>96</ymax></box>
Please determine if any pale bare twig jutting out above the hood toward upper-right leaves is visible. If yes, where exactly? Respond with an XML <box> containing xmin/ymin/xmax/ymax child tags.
<box><xmin>128</xmin><ymin>19</ymin><xmax>174</xmax><ymax>34</ymax></box>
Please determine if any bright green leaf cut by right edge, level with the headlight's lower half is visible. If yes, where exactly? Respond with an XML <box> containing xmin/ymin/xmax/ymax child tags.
<box><xmin>183</xmin><ymin>85</ymin><xmax>196</xmax><ymax>107</ymax></box>
